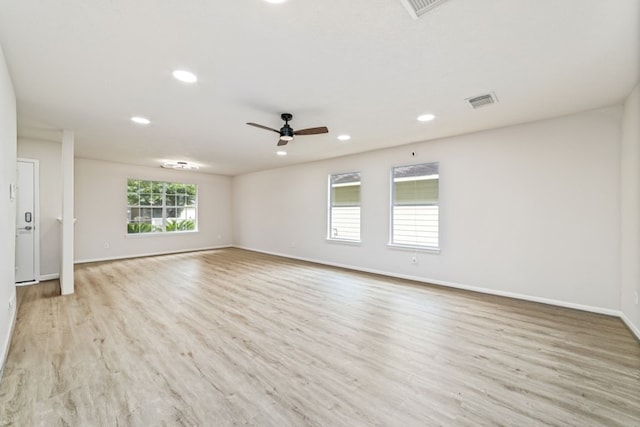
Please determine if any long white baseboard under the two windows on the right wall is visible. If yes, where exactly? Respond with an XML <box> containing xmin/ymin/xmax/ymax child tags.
<box><xmin>234</xmin><ymin>246</ymin><xmax>624</xmax><ymax>320</ymax></box>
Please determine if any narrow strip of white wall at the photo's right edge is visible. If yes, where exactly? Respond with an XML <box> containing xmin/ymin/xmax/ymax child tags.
<box><xmin>620</xmin><ymin>85</ymin><xmax>640</xmax><ymax>337</ymax></box>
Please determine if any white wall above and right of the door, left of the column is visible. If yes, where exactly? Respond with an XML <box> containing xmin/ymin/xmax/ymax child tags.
<box><xmin>18</xmin><ymin>138</ymin><xmax>62</xmax><ymax>280</ymax></box>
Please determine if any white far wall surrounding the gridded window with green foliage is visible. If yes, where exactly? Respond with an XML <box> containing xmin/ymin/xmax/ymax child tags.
<box><xmin>75</xmin><ymin>158</ymin><xmax>232</xmax><ymax>262</ymax></box>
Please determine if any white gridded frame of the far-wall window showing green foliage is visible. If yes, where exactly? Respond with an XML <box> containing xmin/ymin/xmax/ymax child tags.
<box><xmin>126</xmin><ymin>178</ymin><xmax>198</xmax><ymax>237</ymax></box>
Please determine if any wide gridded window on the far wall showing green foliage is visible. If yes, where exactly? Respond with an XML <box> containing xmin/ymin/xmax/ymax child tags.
<box><xmin>127</xmin><ymin>179</ymin><xmax>198</xmax><ymax>234</ymax></box>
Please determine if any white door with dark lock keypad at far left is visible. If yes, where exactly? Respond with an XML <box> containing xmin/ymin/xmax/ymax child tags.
<box><xmin>16</xmin><ymin>159</ymin><xmax>40</xmax><ymax>285</ymax></box>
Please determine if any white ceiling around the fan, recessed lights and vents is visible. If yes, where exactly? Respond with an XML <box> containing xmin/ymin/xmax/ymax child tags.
<box><xmin>0</xmin><ymin>0</ymin><xmax>640</xmax><ymax>175</ymax></box>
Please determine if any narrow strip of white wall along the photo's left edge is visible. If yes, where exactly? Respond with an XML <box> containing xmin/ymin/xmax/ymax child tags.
<box><xmin>0</xmin><ymin>43</ymin><xmax>17</xmax><ymax>376</ymax></box>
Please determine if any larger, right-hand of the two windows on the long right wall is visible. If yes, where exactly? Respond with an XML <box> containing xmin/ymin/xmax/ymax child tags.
<box><xmin>391</xmin><ymin>162</ymin><xmax>440</xmax><ymax>249</ymax></box>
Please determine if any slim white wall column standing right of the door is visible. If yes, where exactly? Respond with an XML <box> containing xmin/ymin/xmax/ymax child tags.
<box><xmin>60</xmin><ymin>130</ymin><xmax>75</xmax><ymax>295</ymax></box>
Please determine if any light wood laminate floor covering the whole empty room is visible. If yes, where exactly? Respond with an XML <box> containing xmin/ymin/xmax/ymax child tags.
<box><xmin>0</xmin><ymin>249</ymin><xmax>640</xmax><ymax>427</ymax></box>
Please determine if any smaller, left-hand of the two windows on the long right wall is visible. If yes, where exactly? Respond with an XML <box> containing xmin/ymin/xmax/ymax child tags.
<box><xmin>328</xmin><ymin>172</ymin><xmax>360</xmax><ymax>241</ymax></box>
